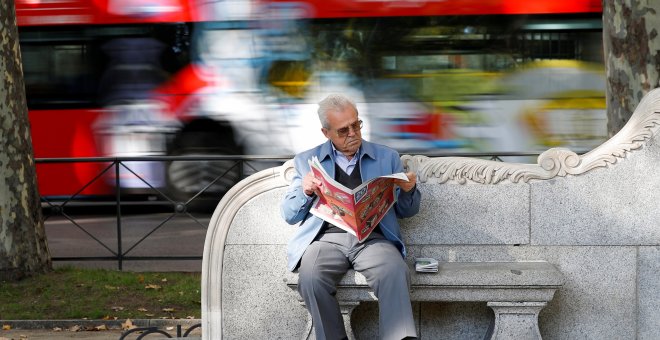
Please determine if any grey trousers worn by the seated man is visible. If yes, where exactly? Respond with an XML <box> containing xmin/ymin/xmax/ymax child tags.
<box><xmin>298</xmin><ymin>233</ymin><xmax>417</xmax><ymax>340</ymax></box>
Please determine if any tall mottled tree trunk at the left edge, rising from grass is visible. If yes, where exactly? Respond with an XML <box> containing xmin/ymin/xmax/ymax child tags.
<box><xmin>0</xmin><ymin>0</ymin><xmax>51</xmax><ymax>281</ymax></box>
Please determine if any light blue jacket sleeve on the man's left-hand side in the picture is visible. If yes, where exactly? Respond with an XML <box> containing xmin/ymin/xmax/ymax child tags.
<box><xmin>280</xmin><ymin>156</ymin><xmax>314</xmax><ymax>224</ymax></box>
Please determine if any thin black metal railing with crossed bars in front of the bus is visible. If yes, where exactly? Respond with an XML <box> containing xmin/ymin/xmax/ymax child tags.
<box><xmin>35</xmin><ymin>152</ymin><xmax>538</xmax><ymax>270</ymax></box>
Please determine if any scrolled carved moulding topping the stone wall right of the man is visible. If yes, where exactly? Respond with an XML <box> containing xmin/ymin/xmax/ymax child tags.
<box><xmin>401</xmin><ymin>89</ymin><xmax>660</xmax><ymax>184</ymax></box>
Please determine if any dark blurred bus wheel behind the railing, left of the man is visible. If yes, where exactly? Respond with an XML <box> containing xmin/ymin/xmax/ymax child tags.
<box><xmin>166</xmin><ymin>122</ymin><xmax>242</xmax><ymax>212</ymax></box>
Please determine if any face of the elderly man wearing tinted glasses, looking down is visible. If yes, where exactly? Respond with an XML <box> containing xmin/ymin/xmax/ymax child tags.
<box><xmin>321</xmin><ymin>107</ymin><xmax>362</xmax><ymax>159</ymax></box>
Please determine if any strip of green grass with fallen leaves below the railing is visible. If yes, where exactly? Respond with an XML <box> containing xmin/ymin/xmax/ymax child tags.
<box><xmin>0</xmin><ymin>268</ymin><xmax>201</xmax><ymax>320</ymax></box>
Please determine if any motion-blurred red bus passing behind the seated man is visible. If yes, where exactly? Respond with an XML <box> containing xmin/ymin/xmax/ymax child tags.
<box><xmin>16</xmin><ymin>0</ymin><xmax>604</xmax><ymax>201</ymax></box>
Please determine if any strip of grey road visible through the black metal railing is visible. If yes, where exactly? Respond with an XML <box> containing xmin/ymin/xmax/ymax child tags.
<box><xmin>44</xmin><ymin>213</ymin><xmax>210</xmax><ymax>272</ymax></box>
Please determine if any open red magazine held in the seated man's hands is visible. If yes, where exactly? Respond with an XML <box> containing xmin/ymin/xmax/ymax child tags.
<box><xmin>309</xmin><ymin>156</ymin><xmax>408</xmax><ymax>242</ymax></box>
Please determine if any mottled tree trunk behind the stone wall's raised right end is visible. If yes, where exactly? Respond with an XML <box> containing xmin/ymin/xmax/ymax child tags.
<box><xmin>603</xmin><ymin>0</ymin><xmax>660</xmax><ymax>137</ymax></box>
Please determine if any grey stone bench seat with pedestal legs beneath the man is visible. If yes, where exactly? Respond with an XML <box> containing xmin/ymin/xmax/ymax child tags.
<box><xmin>284</xmin><ymin>261</ymin><xmax>564</xmax><ymax>339</ymax></box>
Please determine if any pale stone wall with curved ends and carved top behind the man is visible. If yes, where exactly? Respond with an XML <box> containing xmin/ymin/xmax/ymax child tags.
<box><xmin>201</xmin><ymin>90</ymin><xmax>660</xmax><ymax>340</ymax></box>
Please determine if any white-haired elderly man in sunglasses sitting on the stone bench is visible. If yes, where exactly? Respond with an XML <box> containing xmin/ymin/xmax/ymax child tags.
<box><xmin>280</xmin><ymin>95</ymin><xmax>421</xmax><ymax>340</ymax></box>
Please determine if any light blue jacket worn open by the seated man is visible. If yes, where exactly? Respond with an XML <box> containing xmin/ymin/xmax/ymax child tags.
<box><xmin>280</xmin><ymin>140</ymin><xmax>421</xmax><ymax>271</ymax></box>
